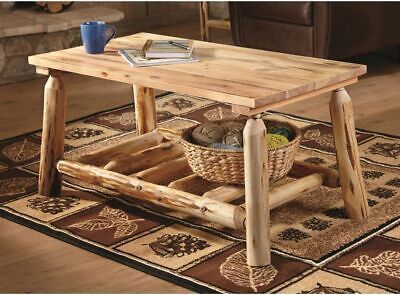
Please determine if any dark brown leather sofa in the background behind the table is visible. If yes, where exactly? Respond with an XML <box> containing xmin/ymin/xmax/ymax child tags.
<box><xmin>229</xmin><ymin>2</ymin><xmax>400</xmax><ymax>59</ymax></box>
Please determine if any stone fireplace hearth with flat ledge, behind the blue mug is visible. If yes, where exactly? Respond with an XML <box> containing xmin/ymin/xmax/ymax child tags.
<box><xmin>0</xmin><ymin>3</ymin><xmax>124</xmax><ymax>84</ymax></box>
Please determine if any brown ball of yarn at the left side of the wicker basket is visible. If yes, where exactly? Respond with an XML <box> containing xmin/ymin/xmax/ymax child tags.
<box><xmin>192</xmin><ymin>123</ymin><xmax>225</xmax><ymax>146</ymax></box>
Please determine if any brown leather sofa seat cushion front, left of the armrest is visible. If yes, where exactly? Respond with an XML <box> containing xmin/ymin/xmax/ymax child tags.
<box><xmin>240</xmin><ymin>2</ymin><xmax>313</xmax><ymax>26</ymax></box>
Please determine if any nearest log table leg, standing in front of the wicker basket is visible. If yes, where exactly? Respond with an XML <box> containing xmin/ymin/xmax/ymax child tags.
<box><xmin>243</xmin><ymin>119</ymin><xmax>271</xmax><ymax>266</ymax></box>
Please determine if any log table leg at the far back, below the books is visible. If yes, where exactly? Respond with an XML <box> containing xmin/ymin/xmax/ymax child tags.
<box><xmin>133</xmin><ymin>85</ymin><xmax>157</xmax><ymax>135</ymax></box>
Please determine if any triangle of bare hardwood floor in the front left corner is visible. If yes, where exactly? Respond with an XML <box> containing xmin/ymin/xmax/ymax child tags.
<box><xmin>0</xmin><ymin>218</ymin><xmax>192</xmax><ymax>293</ymax></box>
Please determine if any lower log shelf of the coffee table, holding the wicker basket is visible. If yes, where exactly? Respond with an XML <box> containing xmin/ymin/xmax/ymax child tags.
<box><xmin>57</xmin><ymin>129</ymin><xmax>339</xmax><ymax>230</ymax></box>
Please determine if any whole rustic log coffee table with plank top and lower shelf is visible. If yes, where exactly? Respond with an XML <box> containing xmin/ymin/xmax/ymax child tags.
<box><xmin>29</xmin><ymin>33</ymin><xmax>368</xmax><ymax>266</ymax></box>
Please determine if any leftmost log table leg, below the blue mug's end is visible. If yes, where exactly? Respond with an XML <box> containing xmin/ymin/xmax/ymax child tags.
<box><xmin>39</xmin><ymin>72</ymin><xmax>66</xmax><ymax>197</ymax></box>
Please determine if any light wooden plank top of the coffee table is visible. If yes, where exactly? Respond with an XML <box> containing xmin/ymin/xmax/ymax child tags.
<box><xmin>29</xmin><ymin>33</ymin><xmax>366</xmax><ymax>108</ymax></box>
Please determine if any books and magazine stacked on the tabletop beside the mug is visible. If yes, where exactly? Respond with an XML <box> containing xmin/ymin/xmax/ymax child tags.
<box><xmin>118</xmin><ymin>40</ymin><xmax>198</xmax><ymax>67</ymax></box>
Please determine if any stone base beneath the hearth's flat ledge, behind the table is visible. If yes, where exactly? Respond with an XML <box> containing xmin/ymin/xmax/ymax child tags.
<box><xmin>0</xmin><ymin>29</ymin><xmax>81</xmax><ymax>84</ymax></box>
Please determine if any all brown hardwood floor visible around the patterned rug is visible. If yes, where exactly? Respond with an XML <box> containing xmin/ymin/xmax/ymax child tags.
<box><xmin>0</xmin><ymin>23</ymin><xmax>400</xmax><ymax>293</ymax></box>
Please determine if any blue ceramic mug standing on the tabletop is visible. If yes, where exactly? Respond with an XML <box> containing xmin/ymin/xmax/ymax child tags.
<box><xmin>81</xmin><ymin>21</ymin><xmax>116</xmax><ymax>54</ymax></box>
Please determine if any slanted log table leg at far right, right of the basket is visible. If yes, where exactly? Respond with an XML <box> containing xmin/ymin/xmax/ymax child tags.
<box><xmin>329</xmin><ymin>88</ymin><xmax>369</xmax><ymax>219</ymax></box>
